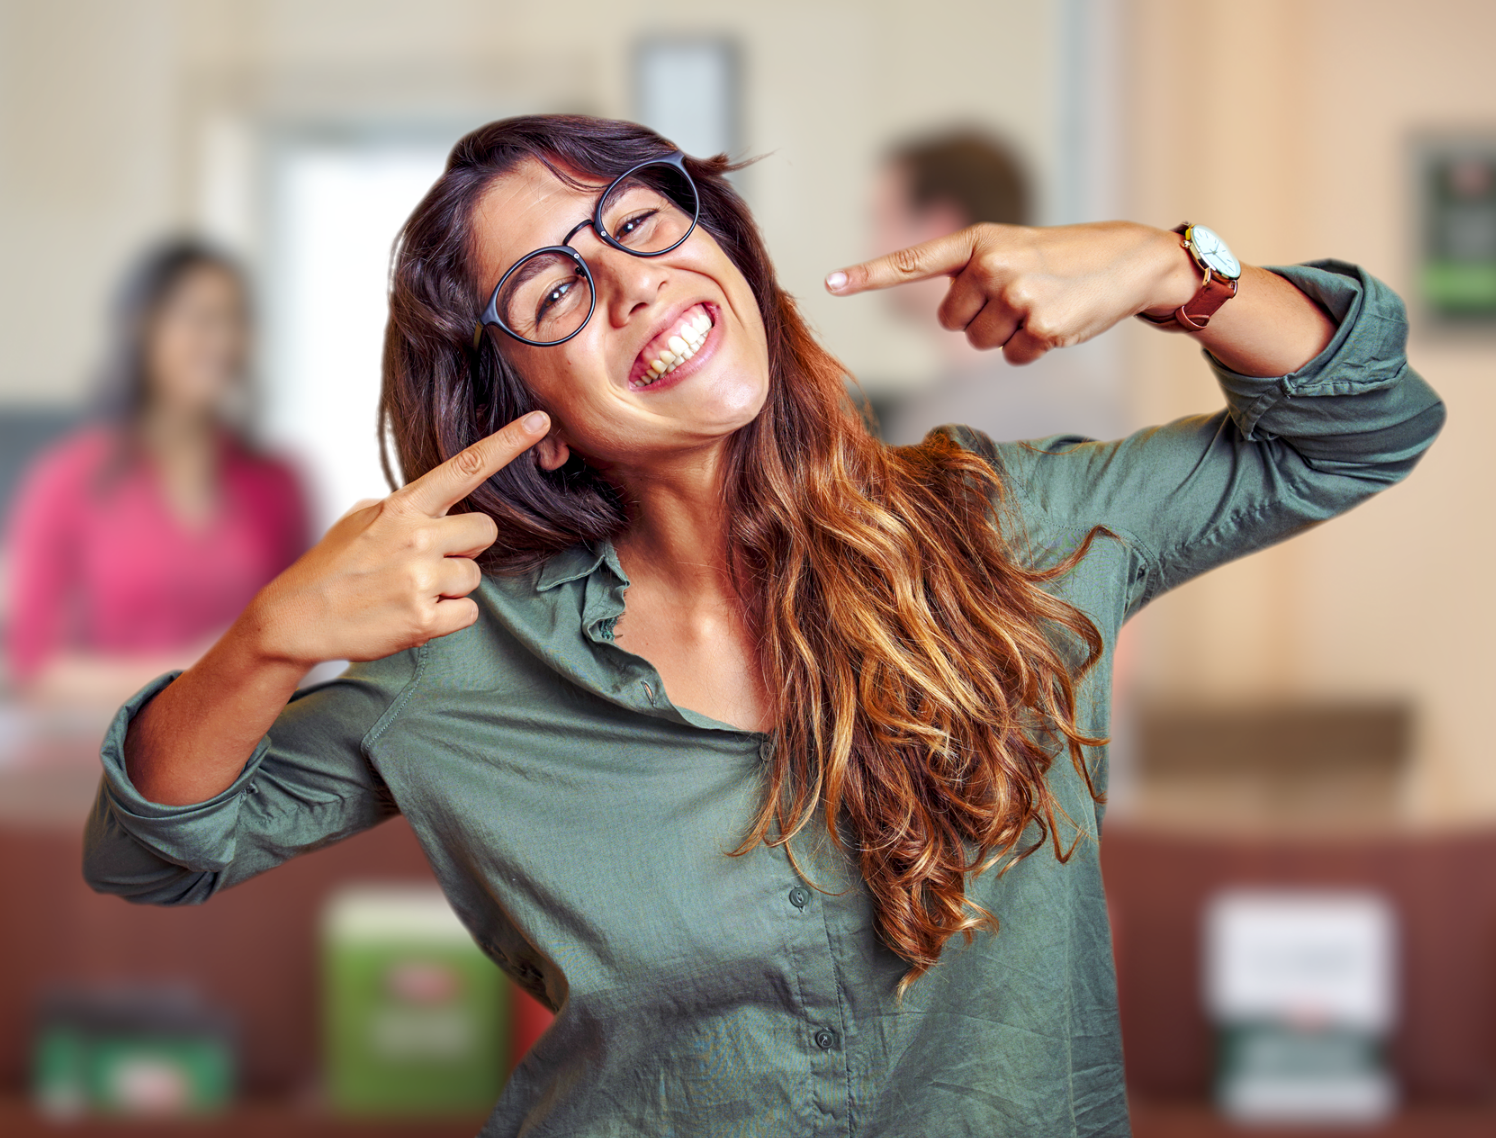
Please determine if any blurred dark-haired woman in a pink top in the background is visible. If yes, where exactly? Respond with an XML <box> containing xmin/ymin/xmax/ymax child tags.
<box><xmin>6</xmin><ymin>239</ymin><xmax>308</xmax><ymax>706</ymax></box>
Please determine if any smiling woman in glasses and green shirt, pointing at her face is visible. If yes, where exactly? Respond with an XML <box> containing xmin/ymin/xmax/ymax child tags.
<box><xmin>87</xmin><ymin>117</ymin><xmax>1442</xmax><ymax>1138</ymax></box>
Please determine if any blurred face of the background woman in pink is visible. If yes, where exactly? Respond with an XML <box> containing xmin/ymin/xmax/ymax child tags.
<box><xmin>145</xmin><ymin>265</ymin><xmax>248</xmax><ymax>416</ymax></box>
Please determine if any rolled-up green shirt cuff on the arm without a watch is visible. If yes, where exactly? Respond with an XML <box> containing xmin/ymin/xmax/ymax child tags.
<box><xmin>99</xmin><ymin>671</ymin><xmax>269</xmax><ymax>872</ymax></box>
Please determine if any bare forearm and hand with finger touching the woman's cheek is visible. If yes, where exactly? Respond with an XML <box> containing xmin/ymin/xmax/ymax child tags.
<box><xmin>124</xmin><ymin>411</ymin><xmax>551</xmax><ymax>806</ymax></box>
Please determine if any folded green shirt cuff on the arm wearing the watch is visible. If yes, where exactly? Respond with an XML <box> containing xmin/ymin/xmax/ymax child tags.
<box><xmin>1204</xmin><ymin>260</ymin><xmax>1408</xmax><ymax>440</ymax></box>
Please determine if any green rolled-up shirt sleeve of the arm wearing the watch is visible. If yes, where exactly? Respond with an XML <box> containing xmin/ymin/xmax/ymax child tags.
<box><xmin>957</xmin><ymin>260</ymin><xmax>1444</xmax><ymax>612</ymax></box>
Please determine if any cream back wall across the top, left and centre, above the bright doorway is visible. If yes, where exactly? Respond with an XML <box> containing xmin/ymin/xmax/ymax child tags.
<box><xmin>0</xmin><ymin>0</ymin><xmax>1062</xmax><ymax>402</ymax></box>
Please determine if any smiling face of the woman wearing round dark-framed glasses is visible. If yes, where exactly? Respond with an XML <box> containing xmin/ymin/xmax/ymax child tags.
<box><xmin>474</xmin><ymin>160</ymin><xmax>769</xmax><ymax>477</ymax></box>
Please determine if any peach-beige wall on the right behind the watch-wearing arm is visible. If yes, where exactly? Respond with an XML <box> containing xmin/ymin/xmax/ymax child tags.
<box><xmin>1126</xmin><ymin>0</ymin><xmax>1496</xmax><ymax>822</ymax></box>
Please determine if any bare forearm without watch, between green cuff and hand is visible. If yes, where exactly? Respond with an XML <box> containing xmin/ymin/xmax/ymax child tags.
<box><xmin>124</xmin><ymin>604</ymin><xmax>307</xmax><ymax>806</ymax></box>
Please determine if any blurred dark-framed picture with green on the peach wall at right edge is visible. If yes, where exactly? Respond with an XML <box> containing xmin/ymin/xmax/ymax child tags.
<box><xmin>1417</xmin><ymin>133</ymin><xmax>1496</xmax><ymax>329</ymax></box>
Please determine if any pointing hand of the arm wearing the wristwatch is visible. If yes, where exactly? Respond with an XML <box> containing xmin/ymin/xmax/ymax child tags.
<box><xmin>826</xmin><ymin>221</ymin><xmax>1200</xmax><ymax>363</ymax></box>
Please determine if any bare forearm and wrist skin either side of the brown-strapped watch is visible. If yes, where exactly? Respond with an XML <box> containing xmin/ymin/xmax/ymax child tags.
<box><xmin>1146</xmin><ymin>232</ymin><xmax>1336</xmax><ymax>377</ymax></box>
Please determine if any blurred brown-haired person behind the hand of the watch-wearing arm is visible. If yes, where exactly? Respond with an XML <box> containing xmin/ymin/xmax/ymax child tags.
<box><xmin>872</xmin><ymin>127</ymin><xmax>1125</xmax><ymax>446</ymax></box>
